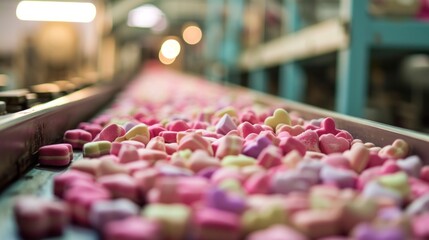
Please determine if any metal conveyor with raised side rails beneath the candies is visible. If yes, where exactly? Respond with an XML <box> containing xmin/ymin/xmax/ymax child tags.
<box><xmin>0</xmin><ymin>63</ymin><xmax>429</xmax><ymax>239</ymax></box>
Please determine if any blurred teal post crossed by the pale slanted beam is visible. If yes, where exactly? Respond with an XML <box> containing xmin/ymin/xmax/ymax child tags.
<box><xmin>279</xmin><ymin>0</ymin><xmax>307</xmax><ymax>101</ymax></box>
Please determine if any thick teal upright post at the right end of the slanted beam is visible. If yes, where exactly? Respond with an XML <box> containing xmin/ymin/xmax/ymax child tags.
<box><xmin>335</xmin><ymin>0</ymin><xmax>370</xmax><ymax>117</ymax></box>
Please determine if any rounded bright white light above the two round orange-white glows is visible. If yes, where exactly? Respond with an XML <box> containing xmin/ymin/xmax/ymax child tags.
<box><xmin>127</xmin><ymin>4</ymin><xmax>166</xmax><ymax>28</ymax></box>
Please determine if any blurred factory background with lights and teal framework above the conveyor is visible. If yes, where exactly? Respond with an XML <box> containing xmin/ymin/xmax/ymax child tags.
<box><xmin>0</xmin><ymin>0</ymin><xmax>429</xmax><ymax>132</ymax></box>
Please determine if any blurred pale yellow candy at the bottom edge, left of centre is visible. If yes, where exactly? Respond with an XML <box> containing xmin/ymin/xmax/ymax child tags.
<box><xmin>143</xmin><ymin>204</ymin><xmax>191</xmax><ymax>239</ymax></box>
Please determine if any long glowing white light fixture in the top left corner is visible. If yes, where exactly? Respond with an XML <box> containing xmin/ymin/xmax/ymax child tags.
<box><xmin>16</xmin><ymin>1</ymin><xmax>97</xmax><ymax>23</ymax></box>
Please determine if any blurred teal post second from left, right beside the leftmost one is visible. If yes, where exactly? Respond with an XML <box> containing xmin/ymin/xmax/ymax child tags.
<box><xmin>222</xmin><ymin>0</ymin><xmax>244</xmax><ymax>84</ymax></box>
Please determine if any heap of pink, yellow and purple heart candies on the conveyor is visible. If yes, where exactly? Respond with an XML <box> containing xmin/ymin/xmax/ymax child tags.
<box><xmin>15</xmin><ymin>64</ymin><xmax>429</xmax><ymax>240</ymax></box>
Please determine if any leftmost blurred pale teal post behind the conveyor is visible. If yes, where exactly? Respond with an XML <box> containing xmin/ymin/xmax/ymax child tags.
<box><xmin>204</xmin><ymin>0</ymin><xmax>224</xmax><ymax>81</ymax></box>
